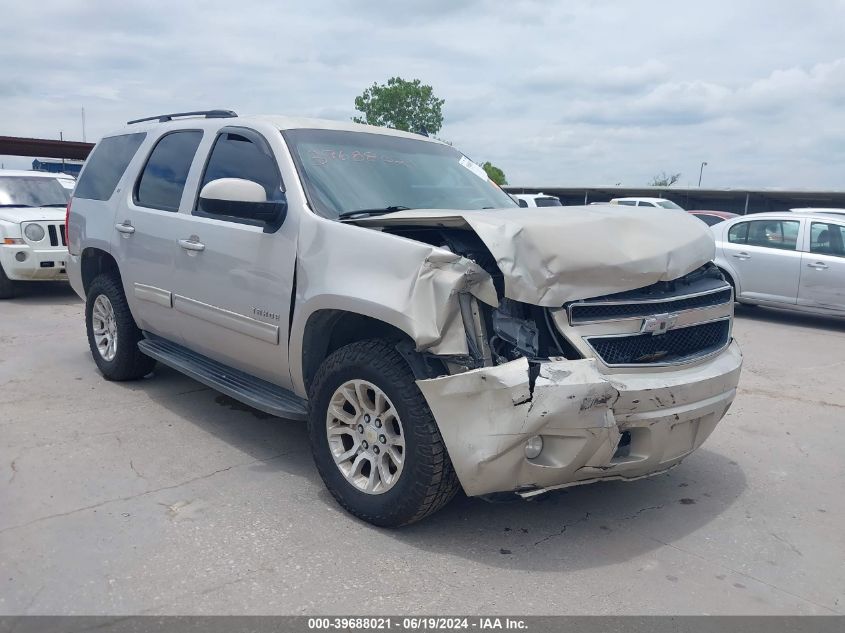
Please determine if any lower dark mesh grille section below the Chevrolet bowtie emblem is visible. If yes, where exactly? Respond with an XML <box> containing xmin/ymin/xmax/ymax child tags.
<box><xmin>586</xmin><ymin>318</ymin><xmax>731</xmax><ymax>366</ymax></box>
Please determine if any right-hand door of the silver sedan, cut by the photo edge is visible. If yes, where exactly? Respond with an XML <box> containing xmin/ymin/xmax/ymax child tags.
<box><xmin>798</xmin><ymin>220</ymin><xmax>845</xmax><ymax>311</ymax></box>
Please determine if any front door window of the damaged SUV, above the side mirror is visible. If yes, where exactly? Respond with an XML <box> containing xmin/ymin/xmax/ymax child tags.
<box><xmin>196</xmin><ymin>130</ymin><xmax>284</xmax><ymax>213</ymax></box>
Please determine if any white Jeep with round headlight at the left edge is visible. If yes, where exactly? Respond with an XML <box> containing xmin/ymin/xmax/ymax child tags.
<box><xmin>0</xmin><ymin>169</ymin><xmax>70</xmax><ymax>299</ymax></box>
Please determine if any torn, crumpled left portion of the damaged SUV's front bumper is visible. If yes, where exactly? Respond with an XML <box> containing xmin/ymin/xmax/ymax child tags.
<box><xmin>417</xmin><ymin>358</ymin><xmax>620</xmax><ymax>496</ymax></box>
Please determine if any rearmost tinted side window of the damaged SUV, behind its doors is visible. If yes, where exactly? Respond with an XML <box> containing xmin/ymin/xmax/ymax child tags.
<box><xmin>73</xmin><ymin>132</ymin><xmax>147</xmax><ymax>200</ymax></box>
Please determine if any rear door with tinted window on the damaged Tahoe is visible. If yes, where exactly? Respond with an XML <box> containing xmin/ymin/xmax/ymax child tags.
<box><xmin>112</xmin><ymin>130</ymin><xmax>203</xmax><ymax>341</ymax></box>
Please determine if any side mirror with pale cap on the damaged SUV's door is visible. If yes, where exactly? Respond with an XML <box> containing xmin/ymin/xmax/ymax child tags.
<box><xmin>199</xmin><ymin>178</ymin><xmax>288</xmax><ymax>233</ymax></box>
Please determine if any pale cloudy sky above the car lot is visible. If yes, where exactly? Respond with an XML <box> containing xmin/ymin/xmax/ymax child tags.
<box><xmin>0</xmin><ymin>0</ymin><xmax>845</xmax><ymax>189</ymax></box>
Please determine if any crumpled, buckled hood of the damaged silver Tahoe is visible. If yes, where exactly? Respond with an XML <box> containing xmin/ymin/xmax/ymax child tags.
<box><xmin>353</xmin><ymin>205</ymin><xmax>715</xmax><ymax>307</ymax></box>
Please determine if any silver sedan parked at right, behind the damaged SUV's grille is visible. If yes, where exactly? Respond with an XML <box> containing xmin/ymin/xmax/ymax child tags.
<box><xmin>711</xmin><ymin>212</ymin><xmax>845</xmax><ymax>315</ymax></box>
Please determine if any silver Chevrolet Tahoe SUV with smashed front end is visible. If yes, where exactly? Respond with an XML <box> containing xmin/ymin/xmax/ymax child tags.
<box><xmin>67</xmin><ymin>110</ymin><xmax>742</xmax><ymax>526</ymax></box>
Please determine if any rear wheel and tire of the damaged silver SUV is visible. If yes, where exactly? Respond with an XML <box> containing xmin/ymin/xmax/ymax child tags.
<box><xmin>85</xmin><ymin>274</ymin><xmax>156</xmax><ymax>381</ymax></box>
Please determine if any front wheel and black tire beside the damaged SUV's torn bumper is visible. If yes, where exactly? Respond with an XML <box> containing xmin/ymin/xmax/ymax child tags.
<box><xmin>308</xmin><ymin>340</ymin><xmax>460</xmax><ymax>527</ymax></box>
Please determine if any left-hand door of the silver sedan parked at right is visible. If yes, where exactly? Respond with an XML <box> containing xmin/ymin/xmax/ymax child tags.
<box><xmin>722</xmin><ymin>219</ymin><xmax>801</xmax><ymax>304</ymax></box>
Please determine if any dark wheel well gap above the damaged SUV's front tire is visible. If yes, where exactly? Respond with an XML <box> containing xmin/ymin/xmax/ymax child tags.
<box><xmin>302</xmin><ymin>310</ymin><xmax>432</xmax><ymax>389</ymax></box>
